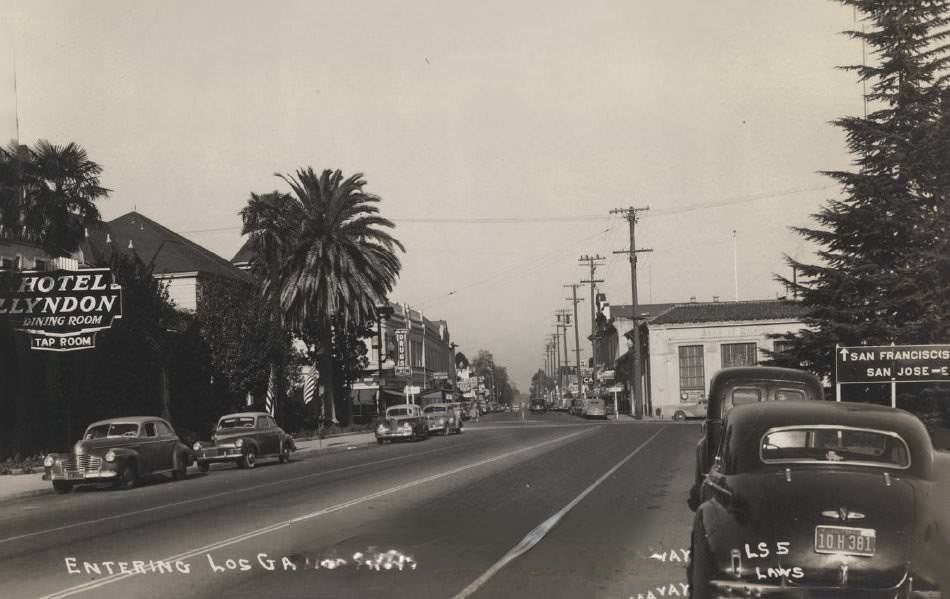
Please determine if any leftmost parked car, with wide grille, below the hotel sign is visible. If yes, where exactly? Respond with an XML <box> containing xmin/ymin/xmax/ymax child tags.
<box><xmin>43</xmin><ymin>416</ymin><xmax>194</xmax><ymax>493</ymax></box>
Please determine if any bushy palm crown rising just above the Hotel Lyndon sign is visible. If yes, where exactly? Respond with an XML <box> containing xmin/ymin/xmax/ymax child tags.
<box><xmin>20</xmin><ymin>139</ymin><xmax>109</xmax><ymax>255</ymax></box>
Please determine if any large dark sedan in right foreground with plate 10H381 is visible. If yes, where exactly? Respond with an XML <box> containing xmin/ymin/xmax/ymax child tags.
<box><xmin>687</xmin><ymin>401</ymin><xmax>950</xmax><ymax>599</ymax></box>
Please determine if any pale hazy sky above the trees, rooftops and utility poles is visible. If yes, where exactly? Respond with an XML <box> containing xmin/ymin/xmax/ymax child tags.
<box><xmin>0</xmin><ymin>0</ymin><xmax>862</xmax><ymax>391</ymax></box>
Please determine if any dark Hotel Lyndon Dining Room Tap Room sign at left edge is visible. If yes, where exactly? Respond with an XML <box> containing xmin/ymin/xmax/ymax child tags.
<box><xmin>0</xmin><ymin>268</ymin><xmax>122</xmax><ymax>351</ymax></box>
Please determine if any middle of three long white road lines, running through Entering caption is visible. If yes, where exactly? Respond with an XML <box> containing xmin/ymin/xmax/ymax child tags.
<box><xmin>41</xmin><ymin>431</ymin><xmax>587</xmax><ymax>599</ymax></box>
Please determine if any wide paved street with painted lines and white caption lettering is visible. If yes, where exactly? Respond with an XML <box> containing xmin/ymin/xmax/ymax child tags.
<box><xmin>0</xmin><ymin>414</ymin><xmax>699</xmax><ymax>599</ymax></box>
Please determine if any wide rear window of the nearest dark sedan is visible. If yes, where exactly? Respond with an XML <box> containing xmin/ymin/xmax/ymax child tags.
<box><xmin>760</xmin><ymin>426</ymin><xmax>910</xmax><ymax>468</ymax></box>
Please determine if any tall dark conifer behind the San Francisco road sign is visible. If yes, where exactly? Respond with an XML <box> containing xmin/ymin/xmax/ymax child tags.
<box><xmin>773</xmin><ymin>0</ymin><xmax>950</xmax><ymax>404</ymax></box>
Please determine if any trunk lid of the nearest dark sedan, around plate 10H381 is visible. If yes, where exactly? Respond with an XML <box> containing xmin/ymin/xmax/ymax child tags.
<box><xmin>740</xmin><ymin>468</ymin><xmax>915</xmax><ymax>588</ymax></box>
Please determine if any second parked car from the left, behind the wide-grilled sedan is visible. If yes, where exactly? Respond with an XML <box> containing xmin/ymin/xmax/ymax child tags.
<box><xmin>193</xmin><ymin>412</ymin><xmax>297</xmax><ymax>472</ymax></box>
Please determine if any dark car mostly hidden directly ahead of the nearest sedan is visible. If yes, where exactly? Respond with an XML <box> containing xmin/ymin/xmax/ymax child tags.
<box><xmin>688</xmin><ymin>366</ymin><xmax>824</xmax><ymax>510</ymax></box>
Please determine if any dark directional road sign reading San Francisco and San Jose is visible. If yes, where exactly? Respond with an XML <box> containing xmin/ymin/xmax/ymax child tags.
<box><xmin>835</xmin><ymin>344</ymin><xmax>950</xmax><ymax>408</ymax></box>
